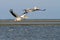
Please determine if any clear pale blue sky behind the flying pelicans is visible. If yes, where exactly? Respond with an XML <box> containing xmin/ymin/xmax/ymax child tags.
<box><xmin>0</xmin><ymin>0</ymin><xmax>60</xmax><ymax>19</ymax></box>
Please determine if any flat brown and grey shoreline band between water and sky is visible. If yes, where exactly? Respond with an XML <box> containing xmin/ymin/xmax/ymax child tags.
<box><xmin>0</xmin><ymin>19</ymin><xmax>60</xmax><ymax>25</ymax></box>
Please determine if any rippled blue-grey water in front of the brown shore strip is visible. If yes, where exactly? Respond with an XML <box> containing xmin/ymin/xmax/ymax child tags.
<box><xmin>0</xmin><ymin>25</ymin><xmax>60</xmax><ymax>40</ymax></box>
